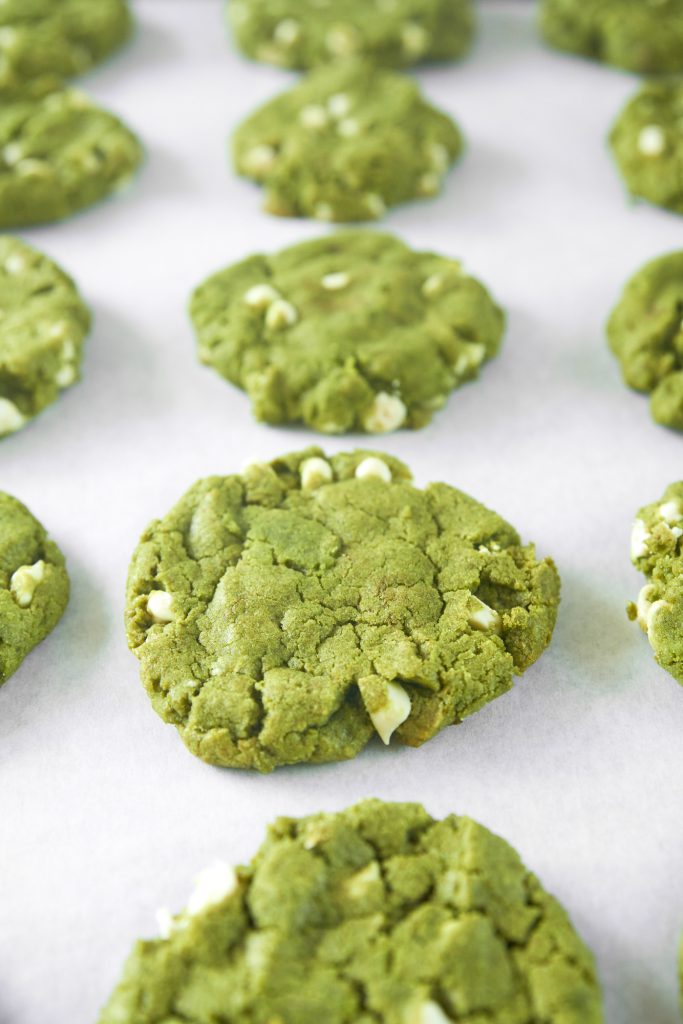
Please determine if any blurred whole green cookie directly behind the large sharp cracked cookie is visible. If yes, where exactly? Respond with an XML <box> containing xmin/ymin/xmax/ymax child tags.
<box><xmin>190</xmin><ymin>230</ymin><xmax>505</xmax><ymax>433</ymax></box>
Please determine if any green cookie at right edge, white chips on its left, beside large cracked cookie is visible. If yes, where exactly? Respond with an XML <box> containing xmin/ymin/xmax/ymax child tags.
<box><xmin>628</xmin><ymin>482</ymin><xmax>683</xmax><ymax>685</ymax></box>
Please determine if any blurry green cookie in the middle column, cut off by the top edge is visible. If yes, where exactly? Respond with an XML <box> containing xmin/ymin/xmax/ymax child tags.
<box><xmin>227</xmin><ymin>0</ymin><xmax>474</xmax><ymax>69</ymax></box>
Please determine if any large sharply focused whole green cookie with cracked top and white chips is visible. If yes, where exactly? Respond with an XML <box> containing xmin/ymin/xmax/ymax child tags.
<box><xmin>126</xmin><ymin>449</ymin><xmax>559</xmax><ymax>771</ymax></box>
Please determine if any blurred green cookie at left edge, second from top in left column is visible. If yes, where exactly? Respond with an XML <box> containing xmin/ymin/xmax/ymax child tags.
<box><xmin>0</xmin><ymin>89</ymin><xmax>142</xmax><ymax>227</ymax></box>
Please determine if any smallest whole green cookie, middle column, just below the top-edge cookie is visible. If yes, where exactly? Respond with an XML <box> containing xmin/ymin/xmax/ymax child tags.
<box><xmin>233</xmin><ymin>60</ymin><xmax>463</xmax><ymax>221</ymax></box>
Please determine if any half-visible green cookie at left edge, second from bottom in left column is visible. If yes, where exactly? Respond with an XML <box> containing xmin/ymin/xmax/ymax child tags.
<box><xmin>0</xmin><ymin>234</ymin><xmax>90</xmax><ymax>437</ymax></box>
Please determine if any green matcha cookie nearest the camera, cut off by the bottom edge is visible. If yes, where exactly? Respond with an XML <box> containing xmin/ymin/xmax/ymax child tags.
<box><xmin>99</xmin><ymin>800</ymin><xmax>603</xmax><ymax>1024</ymax></box>
